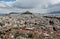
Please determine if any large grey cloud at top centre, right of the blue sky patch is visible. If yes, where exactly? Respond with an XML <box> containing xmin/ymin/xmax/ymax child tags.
<box><xmin>13</xmin><ymin>0</ymin><xmax>48</xmax><ymax>9</ymax></box>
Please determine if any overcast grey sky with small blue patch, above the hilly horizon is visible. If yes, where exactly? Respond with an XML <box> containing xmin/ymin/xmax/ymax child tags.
<box><xmin>0</xmin><ymin>0</ymin><xmax>60</xmax><ymax>13</ymax></box>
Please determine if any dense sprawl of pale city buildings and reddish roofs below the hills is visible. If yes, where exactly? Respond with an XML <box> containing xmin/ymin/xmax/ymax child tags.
<box><xmin>0</xmin><ymin>14</ymin><xmax>60</xmax><ymax>39</ymax></box>
